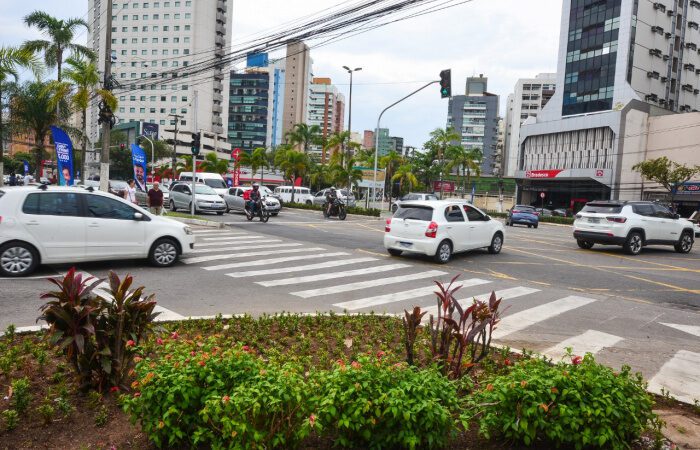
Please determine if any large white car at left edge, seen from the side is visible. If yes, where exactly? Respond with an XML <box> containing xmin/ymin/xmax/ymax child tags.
<box><xmin>0</xmin><ymin>186</ymin><xmax>194</xmax><ymax>277</ymax></box>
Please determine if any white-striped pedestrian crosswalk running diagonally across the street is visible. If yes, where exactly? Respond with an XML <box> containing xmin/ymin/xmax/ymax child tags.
<box><xmin>182</xmin><ymin>229</ymin><xmax>700</xmax><ymax>403</ymax></box>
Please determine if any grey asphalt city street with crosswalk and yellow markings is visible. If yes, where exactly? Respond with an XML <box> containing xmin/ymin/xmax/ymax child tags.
<box><xmin>0</xmin><ymin>209</ymin><xmax>700</xmax><ymax>403</ymax></box>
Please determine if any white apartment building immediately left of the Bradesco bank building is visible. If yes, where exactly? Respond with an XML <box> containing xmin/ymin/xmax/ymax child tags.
<box><xmin>503</xmin><ymin>73</ymin><xmax>557</xmax><ymax>177</ymax></box>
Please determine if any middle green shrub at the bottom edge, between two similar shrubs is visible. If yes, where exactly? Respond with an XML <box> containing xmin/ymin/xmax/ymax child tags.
<box><xmin>306</xmin><ymin>357</ymin><xmax>458</xmax><ymax>448</ymax></box>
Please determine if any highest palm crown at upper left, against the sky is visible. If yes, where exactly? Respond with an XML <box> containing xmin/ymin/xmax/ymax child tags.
<box><xmin>22</xmin><ymin>11</ymin><xmax>95</xmax><ymax>81</ymax></box>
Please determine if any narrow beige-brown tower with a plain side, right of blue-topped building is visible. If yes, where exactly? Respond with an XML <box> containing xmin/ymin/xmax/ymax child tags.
<box><xmin>282</xmin><ymin>42</ymin><xmax>313</xmax><ymax>142</ymax></box>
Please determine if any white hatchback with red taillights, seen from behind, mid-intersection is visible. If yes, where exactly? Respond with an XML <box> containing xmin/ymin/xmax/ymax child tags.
<box><xmin>384</xmin><ymin>200</ymin><xmax>505</xmax><ymax>264</ymax></box>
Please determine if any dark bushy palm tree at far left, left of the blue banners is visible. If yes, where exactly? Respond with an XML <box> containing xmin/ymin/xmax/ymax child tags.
<box><xmin>10</xmin><ymin>81</ymin><xmax>58</xmax><ymax>180</ymax></box>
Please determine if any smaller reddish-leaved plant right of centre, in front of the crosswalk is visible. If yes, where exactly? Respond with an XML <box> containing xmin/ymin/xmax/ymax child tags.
<box><xmin>429</xmin><ymin>275</ymin><xmax>502</xmax><ymax>378</ymax></box>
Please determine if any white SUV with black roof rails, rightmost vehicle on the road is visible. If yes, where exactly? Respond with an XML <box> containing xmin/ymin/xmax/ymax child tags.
<box><xmin>574</xmin><ymin>201</ymin><xmax>695</xmax><ymax>255</ymax></box>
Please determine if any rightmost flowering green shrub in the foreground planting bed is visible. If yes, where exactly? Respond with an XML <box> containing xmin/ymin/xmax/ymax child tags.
<box><xmin>473</xmin><ymin>354</ymin><xmax>656</xmax><ymax>449</ymax></box>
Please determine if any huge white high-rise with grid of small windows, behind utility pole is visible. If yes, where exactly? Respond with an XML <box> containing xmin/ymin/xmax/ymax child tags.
<box><xmin>88</xmin><ymin>0</ymin><xmax>232</xmax><ymax>153</ymax></box>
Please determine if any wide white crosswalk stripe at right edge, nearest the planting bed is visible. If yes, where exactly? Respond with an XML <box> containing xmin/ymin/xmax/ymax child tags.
<box><xmin>648</xmin><ymin>350</ymin><xmax>700</xmax><ymax>404</ymax></box>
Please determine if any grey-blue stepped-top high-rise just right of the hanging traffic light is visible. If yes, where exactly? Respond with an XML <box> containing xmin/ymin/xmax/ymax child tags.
<box><xmin>447</xmin><ymin>75</ymin><xmax>498</xmax><ymax>175</ymax></box>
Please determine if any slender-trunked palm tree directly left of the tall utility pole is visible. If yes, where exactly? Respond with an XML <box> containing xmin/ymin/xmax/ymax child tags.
<box><xmin>50</xmin><ymin>57</ymin><xmax>117</xmax><ymax>182</ymax></box>
